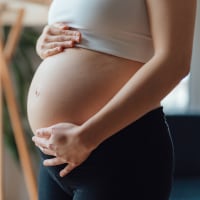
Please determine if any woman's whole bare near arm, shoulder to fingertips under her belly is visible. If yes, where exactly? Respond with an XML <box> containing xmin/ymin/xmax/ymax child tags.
<box><xmin>30</xmin><ymin>0</ymin><xmax>196</xmax><ymax>176</ymax></box>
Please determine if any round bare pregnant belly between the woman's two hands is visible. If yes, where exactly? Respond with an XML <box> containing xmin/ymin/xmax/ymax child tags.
<box><xmin>27</xmin><ymin>48</ymin><xmax>142</xmax><ymax>132</ymax></box>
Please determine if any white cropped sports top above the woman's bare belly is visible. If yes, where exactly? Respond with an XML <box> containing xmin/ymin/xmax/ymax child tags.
<box><xmin>48</xmin><ymin>0</ymin><xmax>154</xmax><ymax>63</ymax></box>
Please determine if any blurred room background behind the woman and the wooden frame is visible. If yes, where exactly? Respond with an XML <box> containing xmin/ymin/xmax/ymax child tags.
<box><xmin>0</xmin><ymin>0</ymin><xmax>200</xmax><ymax>200</ymax></box>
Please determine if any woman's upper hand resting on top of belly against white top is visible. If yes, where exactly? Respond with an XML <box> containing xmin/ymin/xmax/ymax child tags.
<box><xmin>36</xmin><ymin>23</ymin><xmax>81</xmax><ymax>59</ymax></box>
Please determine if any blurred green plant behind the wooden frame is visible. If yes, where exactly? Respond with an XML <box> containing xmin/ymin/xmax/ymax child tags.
<box><xmin>3</xmin><ymin>26</ymin><xmax>39</xmax><ymax>160</ymax></box>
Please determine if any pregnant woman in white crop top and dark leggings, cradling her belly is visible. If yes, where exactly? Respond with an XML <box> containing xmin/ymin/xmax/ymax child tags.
<box><xmin>28</xmin><ymin>0</ymin><xmax>196</xmax><ymax>200</ymax></box>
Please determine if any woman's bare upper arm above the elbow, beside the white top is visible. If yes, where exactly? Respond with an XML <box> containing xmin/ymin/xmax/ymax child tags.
<box><xmin>146</xmin><ymin>0</ymin><xmax>196</xmax><ymax>64</ymax></box>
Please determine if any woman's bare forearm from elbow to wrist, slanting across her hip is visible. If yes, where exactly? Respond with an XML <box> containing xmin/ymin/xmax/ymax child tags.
<box><xmin>80</xmin><ymin>56</ymin><xmax>188</xmax><ymax>147</ymax></box>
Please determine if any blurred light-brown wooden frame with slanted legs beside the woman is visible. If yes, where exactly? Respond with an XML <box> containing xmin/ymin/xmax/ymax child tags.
<box><xmin>0</xmin><ymin>6</ymin><xmax>37</xmax><ymax>200</ymax></box>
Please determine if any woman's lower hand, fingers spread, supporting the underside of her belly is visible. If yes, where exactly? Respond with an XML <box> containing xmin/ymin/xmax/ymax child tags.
<box><xmin>32</xmin><ymin>123</ymin><xmax>92</xmax><ymax>177</ymax></box>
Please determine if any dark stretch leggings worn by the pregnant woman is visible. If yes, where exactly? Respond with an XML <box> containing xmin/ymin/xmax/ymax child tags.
<box><xmin>39</xmin><ymin>107</ymin><xmax>173</xmax><ymax>200</ymax></box>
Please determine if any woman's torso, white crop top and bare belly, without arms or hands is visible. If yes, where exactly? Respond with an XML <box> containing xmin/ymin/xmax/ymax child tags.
<box><xmin>28</xmin><ymin>0</ymin><xmax>153</xmax><ymax>132</ymax></box>
